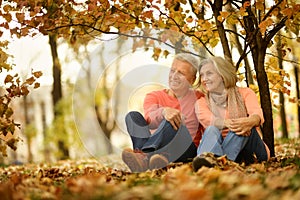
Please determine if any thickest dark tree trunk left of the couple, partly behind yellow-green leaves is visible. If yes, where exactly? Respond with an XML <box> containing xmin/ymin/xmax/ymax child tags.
<box><xmin>49</xmin><ymin>34</ymin><xmax>69</xmax><ymax>159</ymax></box>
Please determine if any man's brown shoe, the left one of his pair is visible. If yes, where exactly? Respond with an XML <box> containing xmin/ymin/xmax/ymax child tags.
<box><xmin>122</xmin><ymin>149</ymin><xmax>148</xmax><ymax>172</ymax></box>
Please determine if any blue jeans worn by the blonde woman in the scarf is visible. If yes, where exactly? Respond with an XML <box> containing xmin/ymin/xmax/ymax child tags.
<box><xmin>197</xmin><ymin>126</ymin><xmax>268</xmax><ymax>163</ymax></box>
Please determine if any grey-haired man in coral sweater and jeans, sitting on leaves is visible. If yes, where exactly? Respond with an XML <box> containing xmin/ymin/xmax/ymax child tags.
<box><xmin>122</xmin><ymin>53</ymin><xmax>203</xmax><ymax>172</ymax></box>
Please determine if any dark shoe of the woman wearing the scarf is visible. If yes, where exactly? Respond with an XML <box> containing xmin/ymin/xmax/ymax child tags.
<box><xmin>192</xmin><ymin>153</ymin><xmax>217</xmax><ymax>172</ymax></box>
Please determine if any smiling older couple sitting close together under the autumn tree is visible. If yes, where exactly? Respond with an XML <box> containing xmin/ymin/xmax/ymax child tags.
<box><xmin>122</xmin><ymin>53</ymin><xmax>269</xmax><ymax>172</ymax></box>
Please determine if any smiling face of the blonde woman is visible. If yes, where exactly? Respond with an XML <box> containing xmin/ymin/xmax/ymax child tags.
<box><xmin>200</xmin><ymin>63</ymin><xmax>225</xmax><ymax>93</ymax></box>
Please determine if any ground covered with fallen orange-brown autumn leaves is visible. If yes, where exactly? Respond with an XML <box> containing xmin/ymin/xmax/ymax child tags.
<box><xmin>0</xmin><ymin>140</ymin><xmax>300</xmax><ymax>200</ymax></box>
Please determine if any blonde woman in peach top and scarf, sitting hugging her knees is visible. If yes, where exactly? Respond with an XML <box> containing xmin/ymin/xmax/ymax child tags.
<box><xmin>193</xmin><ymin>57</ymin><xmax>270</xmax><ymax>171</ymax></box>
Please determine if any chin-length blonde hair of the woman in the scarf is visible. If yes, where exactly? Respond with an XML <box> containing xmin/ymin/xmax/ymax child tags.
<box><xmin>199</xmin><ymin>56</ymin><xmax>237</xmax><ymax>88</ymax></box>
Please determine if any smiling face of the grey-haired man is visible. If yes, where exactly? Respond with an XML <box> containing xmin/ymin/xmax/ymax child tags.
<box><xmin>169</xmin><ymin>59</ymin><xmax>196</xmax><ymax>91</ymax></box>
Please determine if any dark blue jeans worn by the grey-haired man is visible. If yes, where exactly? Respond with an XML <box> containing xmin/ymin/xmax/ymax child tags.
<box><xmin>125</xmin><ymin>111</ymin><xmax>197</xmax><ymax>162</ymax></box>
